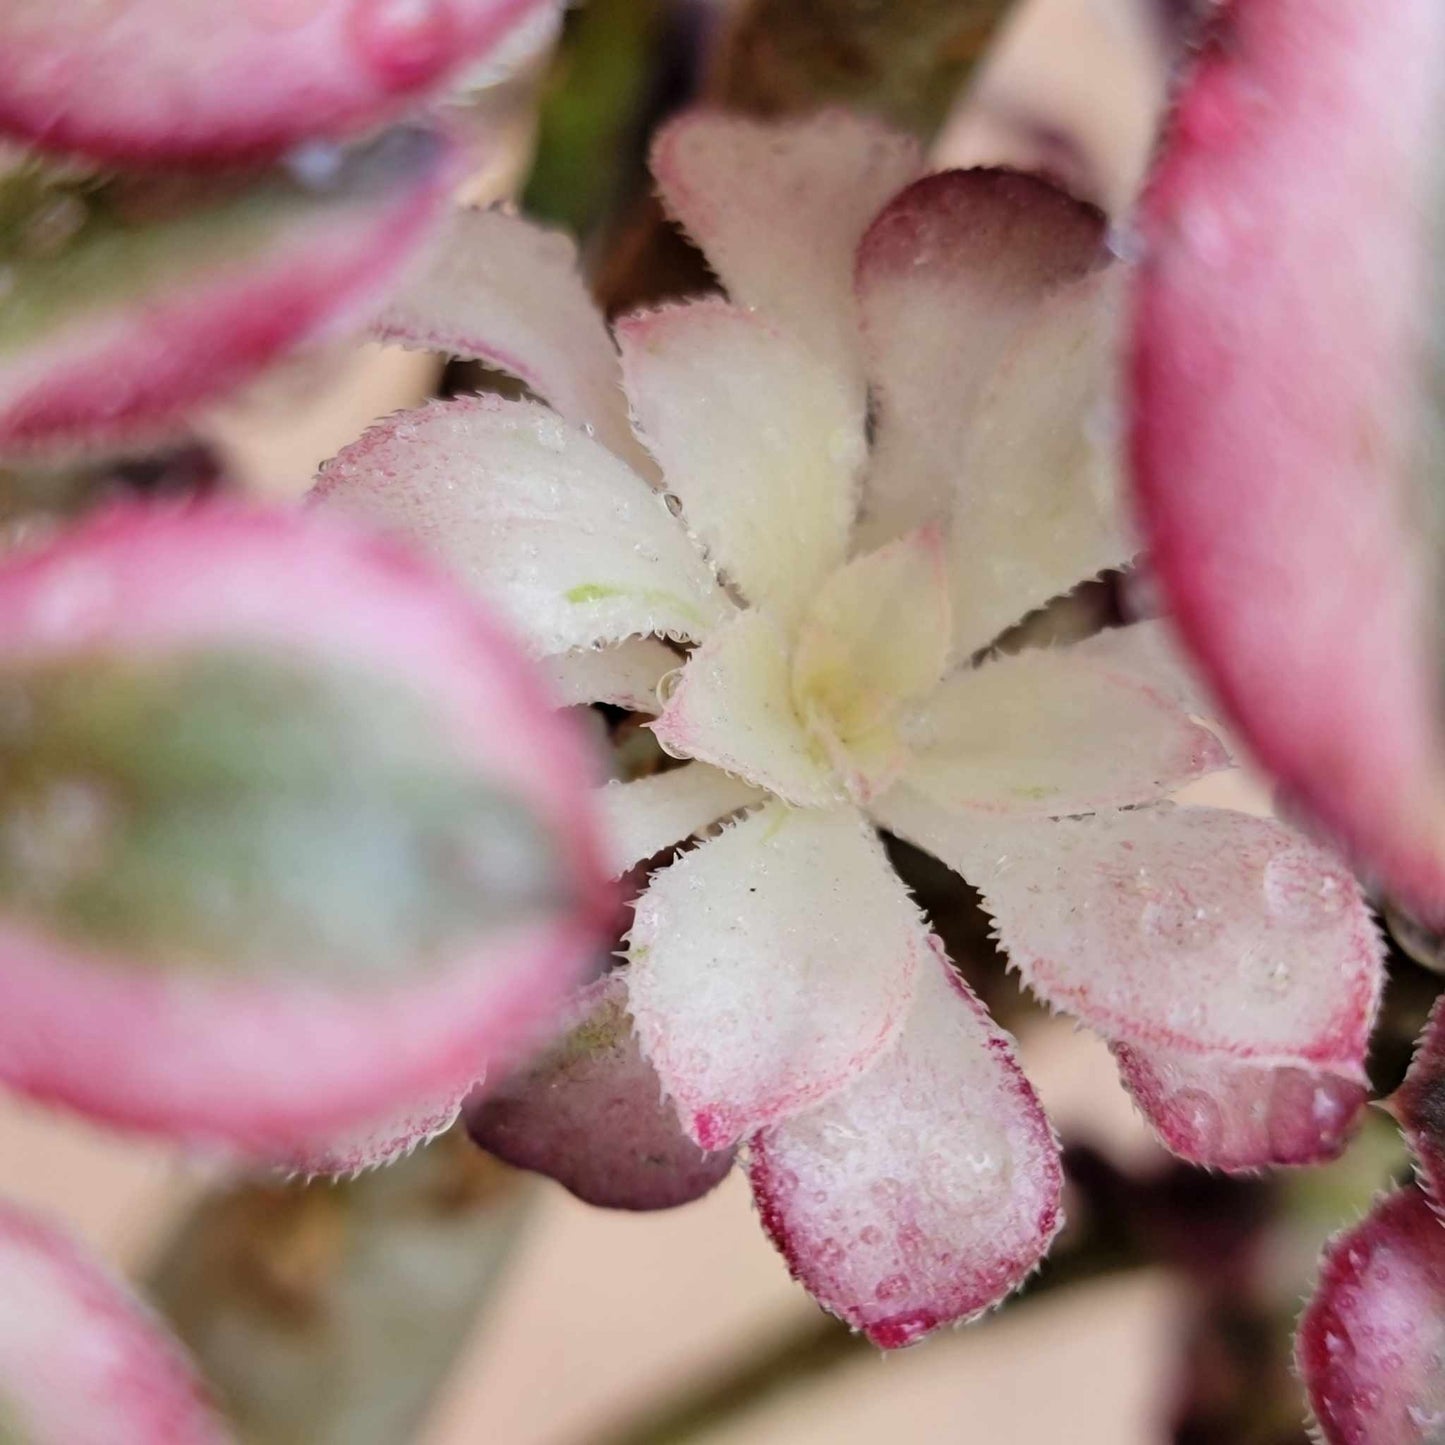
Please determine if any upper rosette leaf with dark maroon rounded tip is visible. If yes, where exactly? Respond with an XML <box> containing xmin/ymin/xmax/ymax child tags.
<box><xmin>857</xmin><ymin>171</ymin><xmax>1104</xmax><ymax>546</ymax></box>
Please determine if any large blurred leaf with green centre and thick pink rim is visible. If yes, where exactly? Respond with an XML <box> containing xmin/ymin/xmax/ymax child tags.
<box><xmin>0</xmin><ymin>506</ymin><xmax>608</xmax><ymax>1160</ymax></box>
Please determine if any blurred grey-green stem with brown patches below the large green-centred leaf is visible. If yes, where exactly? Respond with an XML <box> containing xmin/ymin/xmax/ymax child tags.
<box><xmin>152</xmin><ymin>1130</ymin><xmax>532</xmax><ymax>1445</ymax></box>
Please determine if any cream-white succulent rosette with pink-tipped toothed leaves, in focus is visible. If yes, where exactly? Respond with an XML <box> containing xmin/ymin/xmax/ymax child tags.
<box><xmin>315</xmin><ymin>113</ymin><xmax>1380</xmax><ymax>1347</ymax></box>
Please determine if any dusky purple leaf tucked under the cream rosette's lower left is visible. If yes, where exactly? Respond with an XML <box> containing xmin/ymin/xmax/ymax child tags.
<box><xmin>467</xmin><ymin>974</ymin><xmax>734</xmax><ymax>1209</ymax></box>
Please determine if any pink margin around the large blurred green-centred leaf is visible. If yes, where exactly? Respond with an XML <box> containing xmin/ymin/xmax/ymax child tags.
<box><xmin>0</xmin><ymin>504</ymin><xmax>611</xmax><ymax>1162</ymax></box>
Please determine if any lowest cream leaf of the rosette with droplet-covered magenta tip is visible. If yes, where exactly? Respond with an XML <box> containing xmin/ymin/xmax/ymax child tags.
<box><xmin>749</xmin><ymin>941</ymin><xmax>1062</xmax><ymax>1350</ymax></box>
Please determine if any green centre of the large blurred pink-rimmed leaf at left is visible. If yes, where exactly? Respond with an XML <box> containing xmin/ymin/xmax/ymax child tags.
<box><xmin>0</xmin><ymin>650</ymin><xmax>561</xmax><ymax>980</ymax></box>
